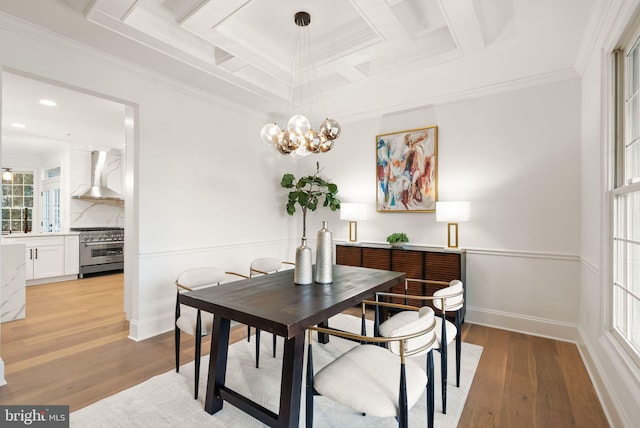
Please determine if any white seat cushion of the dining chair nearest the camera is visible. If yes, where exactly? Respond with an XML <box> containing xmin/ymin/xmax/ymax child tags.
<box><xmin>313</xmin><ymin>345</ymin><xmax>427</xmax><ymax>417</ymax></box>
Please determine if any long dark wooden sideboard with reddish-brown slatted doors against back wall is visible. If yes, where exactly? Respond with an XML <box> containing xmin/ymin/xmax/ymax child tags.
<box><xmin>336</xmin><ymin>243</ymin><xmax>467</xmax><ymax>320</ymax></box>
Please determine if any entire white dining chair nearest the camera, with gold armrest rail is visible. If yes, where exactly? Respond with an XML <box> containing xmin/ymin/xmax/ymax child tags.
<box><xmin>305</xmin><ymin>301</ymin><xmax>436</xmax><ymax>428</ymax></box>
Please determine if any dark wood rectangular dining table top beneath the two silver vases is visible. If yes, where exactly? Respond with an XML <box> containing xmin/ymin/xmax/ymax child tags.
<box><xmin>180</xmin><ymin>265</ymin><xmax>405</xmax><ymax>339</ymax></box>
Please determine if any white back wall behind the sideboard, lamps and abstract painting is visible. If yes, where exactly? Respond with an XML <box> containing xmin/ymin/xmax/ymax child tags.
<box><xmin>299</xmin><ymin>79</ymin><xmax>580</xmax><ymax>340</ymax></box>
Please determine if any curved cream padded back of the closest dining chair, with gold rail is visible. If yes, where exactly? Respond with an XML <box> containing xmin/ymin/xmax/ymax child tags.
<box><xmin>383</xmin><ymin>306</ymin><xmax>437</xmax><ymax>356</ymax></box>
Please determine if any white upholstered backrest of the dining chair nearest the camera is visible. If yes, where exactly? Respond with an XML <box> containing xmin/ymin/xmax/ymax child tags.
<box><xmin>379</xmin><ymin>306</ymin><xmax>435</xmax><ymax>355</ymax></box>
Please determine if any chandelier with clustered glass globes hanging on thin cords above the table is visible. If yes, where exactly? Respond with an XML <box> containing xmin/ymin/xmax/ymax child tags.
<box><xmin>260</xmin><ymin>12</ymin><xmax>341</xmax><ymax>157</ymax></box>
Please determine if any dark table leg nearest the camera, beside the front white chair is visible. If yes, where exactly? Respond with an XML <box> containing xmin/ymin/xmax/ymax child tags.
<box><xmin>278</xmin><ymin>332</ymin><xmax>305</xmax><ymax>428</ymax></box>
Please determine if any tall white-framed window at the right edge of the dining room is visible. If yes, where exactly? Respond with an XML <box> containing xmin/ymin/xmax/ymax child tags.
<box><xmin>611</xmin><ymin>35</ymin><xmax>640</xmax><ymax>364</ymax></box>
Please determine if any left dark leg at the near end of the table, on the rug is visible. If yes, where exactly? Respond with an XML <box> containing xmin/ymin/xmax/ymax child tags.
<box><xmin>204</xmin><ymin>317</ymin><xmax>231</xmax><ymax>414</ymax></box>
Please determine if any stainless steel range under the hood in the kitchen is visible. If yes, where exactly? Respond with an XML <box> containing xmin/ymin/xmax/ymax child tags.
<box><xmin>71</xmin><ymin>227</ymin><xmax>124</xmax><ymax>278</ymax></box>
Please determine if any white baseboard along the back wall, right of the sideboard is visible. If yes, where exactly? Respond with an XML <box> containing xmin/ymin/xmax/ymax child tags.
<box><xmin>465</xmin><ymin>306</ymin><xmax>578</xmax><ymax>343</ymax></box>
